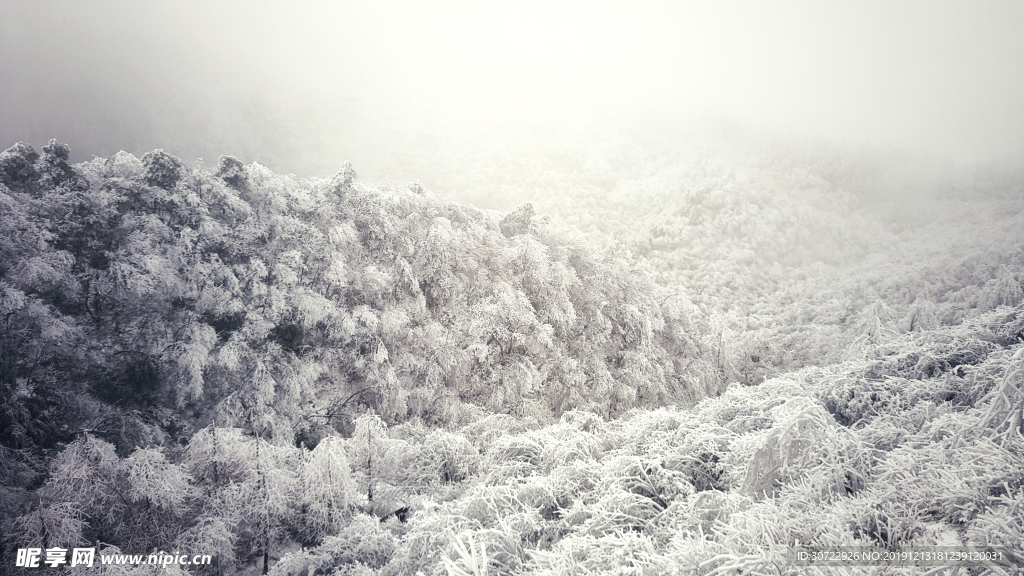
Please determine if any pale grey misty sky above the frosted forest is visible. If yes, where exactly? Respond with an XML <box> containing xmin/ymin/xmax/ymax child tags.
<box><xmin>0</xmin><ymin>0</ymin><xmax>1024</xmax><ymax>178</ymax></box>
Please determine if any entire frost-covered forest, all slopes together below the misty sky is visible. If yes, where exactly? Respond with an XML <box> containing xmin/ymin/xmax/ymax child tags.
<box><xmin>0</xmin><ymin>135</ymin><xmax>1024</xmax><ymax>576</ymax></box>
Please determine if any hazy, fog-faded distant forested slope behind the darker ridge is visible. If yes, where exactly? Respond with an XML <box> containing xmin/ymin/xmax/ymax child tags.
<box><xmin>389</xmin><ymin>125</ymin><xmax>1024</xmax><ymax>384</ymax></box>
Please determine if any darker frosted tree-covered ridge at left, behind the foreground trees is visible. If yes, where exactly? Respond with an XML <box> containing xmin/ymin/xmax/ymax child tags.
<box><xmin>2</xmin><ymin>138</ymin><xmax>717</xmax><ymax>438</ymax></box>
